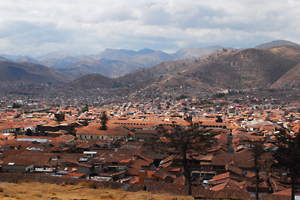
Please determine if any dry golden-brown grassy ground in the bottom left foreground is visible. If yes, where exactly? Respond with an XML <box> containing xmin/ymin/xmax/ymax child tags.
<box><xmin>0</xmin><ymin>182</ymin><xmax>194</xmax><ymax>200</ymax></box>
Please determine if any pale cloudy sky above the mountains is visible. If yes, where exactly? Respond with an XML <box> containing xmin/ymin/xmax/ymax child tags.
<box><xmin>0</xmin><ymin>0</ymin><xmax>300</xmax><ymax>56</ymax></box>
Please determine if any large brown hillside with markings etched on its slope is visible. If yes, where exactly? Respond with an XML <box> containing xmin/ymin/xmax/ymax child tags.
<box><xmin>117</xmin><ymin>49</ymin><xmax>297</xmax><ymax>88</ymax></box>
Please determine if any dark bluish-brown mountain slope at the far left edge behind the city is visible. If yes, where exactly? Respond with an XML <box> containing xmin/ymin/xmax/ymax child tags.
<box><xmin>0</xmin><ymin>61</ymin><xmax>72</xmax><ymax>86</ymax></box>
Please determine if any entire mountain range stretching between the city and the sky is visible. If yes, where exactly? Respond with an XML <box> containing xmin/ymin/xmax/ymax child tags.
<box><xmin>0</xmin><ymin>40</ymin><xmax>300</xmax><ymax>94</ymax></box>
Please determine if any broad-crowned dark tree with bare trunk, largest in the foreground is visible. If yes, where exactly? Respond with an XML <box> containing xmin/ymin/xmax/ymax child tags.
<box><xmin>155</xmin><ymin>123</ymin><xmax>218</xmax><ymax>194</ymax></box>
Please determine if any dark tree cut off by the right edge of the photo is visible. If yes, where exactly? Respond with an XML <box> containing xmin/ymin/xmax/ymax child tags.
<box><xmin>272</xmin><ymin>129</ymin><xmax>300</xmax><ymax>200</ymax></box>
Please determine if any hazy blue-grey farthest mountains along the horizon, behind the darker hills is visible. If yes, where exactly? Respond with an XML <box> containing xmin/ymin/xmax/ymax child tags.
<box><xmin>45</xmin><ymin>46</ymin><xmax>227</xmax><ymax>78</ymax></box>
